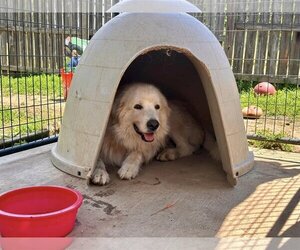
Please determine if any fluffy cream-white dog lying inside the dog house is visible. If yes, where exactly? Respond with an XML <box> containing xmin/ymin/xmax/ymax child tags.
<box><xmin>87</xmin><ymin>83</ymin><xmax>218</xmax><ymax>185</ymax></box>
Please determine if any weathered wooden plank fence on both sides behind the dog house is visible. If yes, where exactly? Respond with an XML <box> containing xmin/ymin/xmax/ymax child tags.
<box><xmin>0</xmin><ymin>0</ymin><xmax>300</xmax><ymax>84</ymax></box>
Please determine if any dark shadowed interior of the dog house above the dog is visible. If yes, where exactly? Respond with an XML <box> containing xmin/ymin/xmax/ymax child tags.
<box><xmin>120</xmin><ymin>48</ymin><xmax>213</xmax><ymax>129</ymax></box>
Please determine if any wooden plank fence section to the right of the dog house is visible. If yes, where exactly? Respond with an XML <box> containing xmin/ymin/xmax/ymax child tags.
<box><xmin>195</xmin><ymin>0</ymin><xmax>300</xmax><ymax>84</ymax></box>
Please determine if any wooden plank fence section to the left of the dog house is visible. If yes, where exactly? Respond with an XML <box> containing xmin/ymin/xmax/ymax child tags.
<box><xmin>0</xmin><ymin>13</ymin><xmax>110</xmax><ymax>73</ymax></box>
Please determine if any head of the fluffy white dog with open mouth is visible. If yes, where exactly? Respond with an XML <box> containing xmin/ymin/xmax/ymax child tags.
<box><xmin>113</xmin><ymin>83</ymin><xmax>170</xmax><ymax>143</ymax></box>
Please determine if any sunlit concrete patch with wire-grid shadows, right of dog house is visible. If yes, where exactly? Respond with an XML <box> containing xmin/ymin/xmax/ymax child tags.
<box><xmin>217</xmin><ymin>160</ymin><xmax>300</xmax><ymax>237</ymax></box>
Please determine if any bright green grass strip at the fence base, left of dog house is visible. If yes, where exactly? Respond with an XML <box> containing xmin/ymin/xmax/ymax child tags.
<box><xmin>0</xmin><ymin>74</ymin><xmax>62</xmax><ymax>98</ymax></box>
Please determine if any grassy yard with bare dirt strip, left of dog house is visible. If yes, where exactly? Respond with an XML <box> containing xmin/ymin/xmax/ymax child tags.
<box><xmin>0</xmin><ymin>74</ymin><xmax>62</xmax><ymax>139</ymax></box>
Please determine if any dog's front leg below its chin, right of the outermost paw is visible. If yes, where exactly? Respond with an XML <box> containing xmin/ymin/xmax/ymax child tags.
<box><xmin>118</xmin><ymin>152</ymin><xmax>144</xmax><ymax>180</ymax></box>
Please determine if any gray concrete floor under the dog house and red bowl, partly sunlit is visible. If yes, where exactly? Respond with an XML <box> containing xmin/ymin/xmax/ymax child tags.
<box><xmin>0</xmin><ymin>145</ymin><xmax>300</xmax><ymax>237</ymax></box>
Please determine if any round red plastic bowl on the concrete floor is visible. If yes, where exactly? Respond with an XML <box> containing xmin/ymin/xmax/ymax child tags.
<box><xmin>0</xmin><ymin>186</ymin><xmax>83</xmax><ymax>237</ymax></box>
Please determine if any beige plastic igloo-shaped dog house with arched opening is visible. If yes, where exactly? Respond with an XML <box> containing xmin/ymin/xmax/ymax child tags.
<box><xmin>52</xmin><ymin>0</ymin><xmax>254</xmax><ymax>185</ymax></box>
